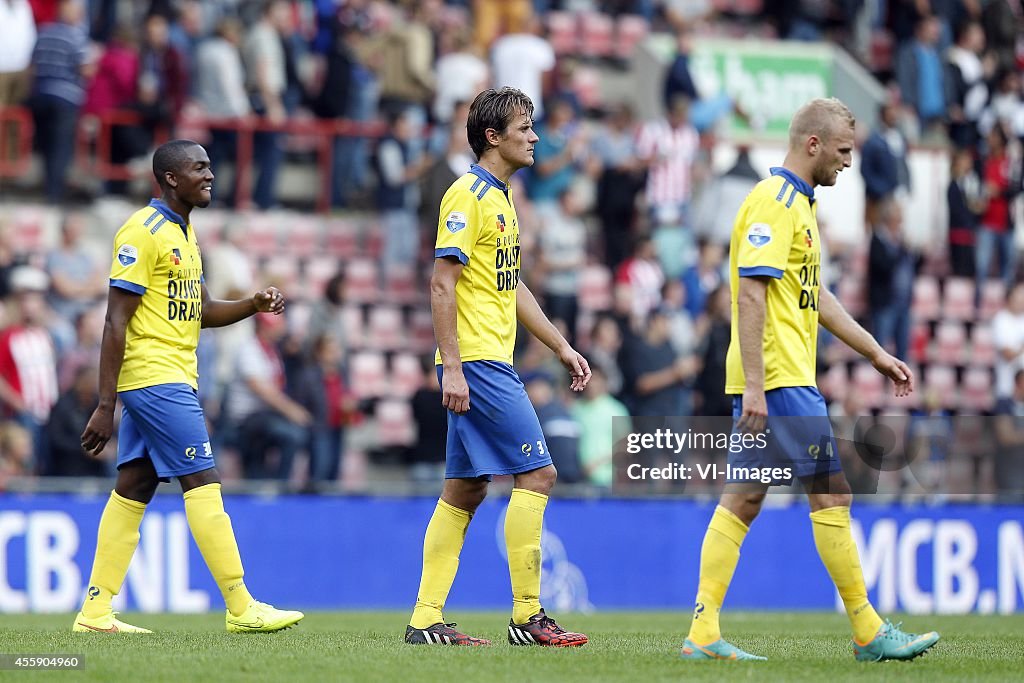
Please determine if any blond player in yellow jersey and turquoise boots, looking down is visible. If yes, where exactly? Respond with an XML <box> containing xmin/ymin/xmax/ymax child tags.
<box><xmin>682</xmin><ymin>98</ymin><xmax>939</xmax><ymax>661</ymax></box>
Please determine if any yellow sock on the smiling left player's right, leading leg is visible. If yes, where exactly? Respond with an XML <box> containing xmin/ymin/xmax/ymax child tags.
<box><xmin>184</xmin><ymin>483</ymin><xmax>253</xmax><ymax>616</ymax></box>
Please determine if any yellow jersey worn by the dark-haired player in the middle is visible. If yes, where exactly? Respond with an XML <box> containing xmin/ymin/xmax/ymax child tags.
<box><xmin>434</xmin><ymin>164</ymin><xmax>519</xmax><ymax>365</ymax></box>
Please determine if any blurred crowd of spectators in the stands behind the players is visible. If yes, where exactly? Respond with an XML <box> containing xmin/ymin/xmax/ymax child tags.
<box><xmin>0</xmin><ymin>0</ymin><xmax>1024</xmax><ymax>501</ymax></box>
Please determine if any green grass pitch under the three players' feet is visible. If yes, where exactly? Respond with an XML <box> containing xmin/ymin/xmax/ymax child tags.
<box><xmin>0</xmin><ymin>610</ymin><xmax>1024</xmax><ymax>683</ymax></box>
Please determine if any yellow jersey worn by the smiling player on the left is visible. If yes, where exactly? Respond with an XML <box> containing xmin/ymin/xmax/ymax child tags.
<box><xmin>111</xmin><ymin>200</ymin><xmax>203</xmax><ymax>391</ymax></box>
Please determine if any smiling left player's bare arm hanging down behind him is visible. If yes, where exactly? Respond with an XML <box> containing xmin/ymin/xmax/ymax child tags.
<box><xmin>82</xmin><ymin>287</ymin><xmax>142</xmax><ymax>458</ymax></box>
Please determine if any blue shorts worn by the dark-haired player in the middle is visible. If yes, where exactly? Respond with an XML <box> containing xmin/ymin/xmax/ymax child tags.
<box><xmin>437</xmin><ymin>360</ymin><xmax>551</xmax><ymax>480</ymax></box>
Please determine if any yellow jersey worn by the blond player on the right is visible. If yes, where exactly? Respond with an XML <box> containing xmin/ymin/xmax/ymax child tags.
<box><xmin>725</xmin><ymin>168</ymin><xmax>821</xmax><ymax>394</ymax></box>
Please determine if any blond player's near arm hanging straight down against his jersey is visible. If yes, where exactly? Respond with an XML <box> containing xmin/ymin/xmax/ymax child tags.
<box><xmin>737</xmin><ymin>276</ymin><xmax>769</xmax><ymax>432</ymax></box>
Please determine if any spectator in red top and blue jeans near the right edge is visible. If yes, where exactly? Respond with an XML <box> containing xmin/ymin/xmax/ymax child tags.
<box><xmin>975</xmin><ymin>124</ymin><xmax>1020</xmax><ymax>292</ymax></box>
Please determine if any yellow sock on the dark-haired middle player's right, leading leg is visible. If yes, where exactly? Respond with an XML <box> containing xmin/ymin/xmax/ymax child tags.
<box><xmin>505</xmin><ymin>488</ymin><xmax>548</xmax><ymax>624</ymax></box>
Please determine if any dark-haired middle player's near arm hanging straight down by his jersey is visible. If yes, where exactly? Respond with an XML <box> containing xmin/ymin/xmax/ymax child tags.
<box><xmin>430</xmin><ymin>257</ymin><xmax>469</xmax><ymax>414</ymax></box>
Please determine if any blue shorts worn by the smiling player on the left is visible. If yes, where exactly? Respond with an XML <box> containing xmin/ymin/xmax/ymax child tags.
<box><xmin>118</xmin><ymin>384</ymin><xmax>214</xmax><ymax>481</ymax></box>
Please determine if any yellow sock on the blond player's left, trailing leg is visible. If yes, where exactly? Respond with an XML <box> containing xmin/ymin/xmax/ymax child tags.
<box><xmin>687</xmin><ymin>505</ymin><xmax>750</xmax><ymax>645</ymax></box>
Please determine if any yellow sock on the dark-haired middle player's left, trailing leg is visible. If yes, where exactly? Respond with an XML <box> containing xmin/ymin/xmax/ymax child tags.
<box><xmin>409</xmin><ymin>500</ymin><xmax>473</xmax><ymax>629</ymax></box>
